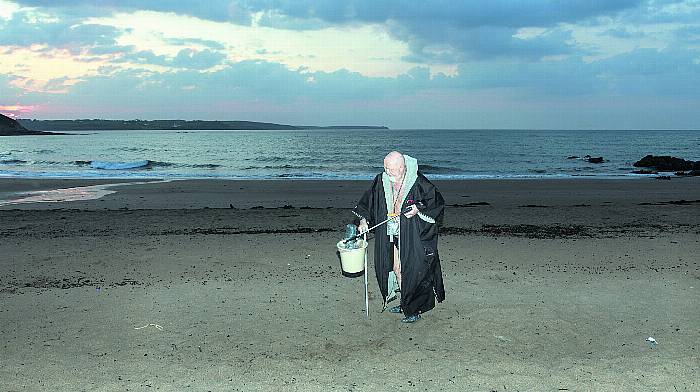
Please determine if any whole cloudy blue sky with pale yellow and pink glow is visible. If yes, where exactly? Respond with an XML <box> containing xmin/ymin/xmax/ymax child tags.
<box><xmin>0</xmin><ymin>0</ymin><xmax>700</xmax><ymax>129</ymax></box>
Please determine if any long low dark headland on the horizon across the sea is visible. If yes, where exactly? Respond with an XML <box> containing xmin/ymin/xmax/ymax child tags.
<box><xmin>18</xmin><ymin>119</ymin><xmax>388</xmax><ymax>132</ymax></box>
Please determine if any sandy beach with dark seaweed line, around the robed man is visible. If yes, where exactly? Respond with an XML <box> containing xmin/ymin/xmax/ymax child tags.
<box><xmin>0</xmin><ymin>178</ymin><xmax>700</xmax><ymax>392</ymax></box>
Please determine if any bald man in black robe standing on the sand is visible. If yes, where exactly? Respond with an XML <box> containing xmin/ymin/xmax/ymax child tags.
<box><xmin>353</xmin><ymin>151</ymin><xmax>445</xmax><ymax>323</ymax></box>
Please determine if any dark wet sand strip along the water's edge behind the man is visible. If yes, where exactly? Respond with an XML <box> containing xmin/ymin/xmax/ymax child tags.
<box><xmin>0</xmin><ymin>177</ymin><xmax>700</xmax><ymax>209</ymax></box>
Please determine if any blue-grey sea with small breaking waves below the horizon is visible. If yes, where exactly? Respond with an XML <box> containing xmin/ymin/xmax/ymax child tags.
<box><xmin>0</xmin><ymin>129</ymin><xmax>700</xmax><ymax>180</ymax></box>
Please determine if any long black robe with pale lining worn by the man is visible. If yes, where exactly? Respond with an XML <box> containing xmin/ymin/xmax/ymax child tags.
<box><xmin>353</xmin><ymin>172</ymin><xmax>445</xmax><ymax>315</ymax></box>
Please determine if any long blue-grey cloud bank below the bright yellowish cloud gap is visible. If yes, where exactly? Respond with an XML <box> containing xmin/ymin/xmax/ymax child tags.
<box><xmin>16</xmin><ymin>45</ymin><xmax>700</xmax><ymax>110</ymax></box>
